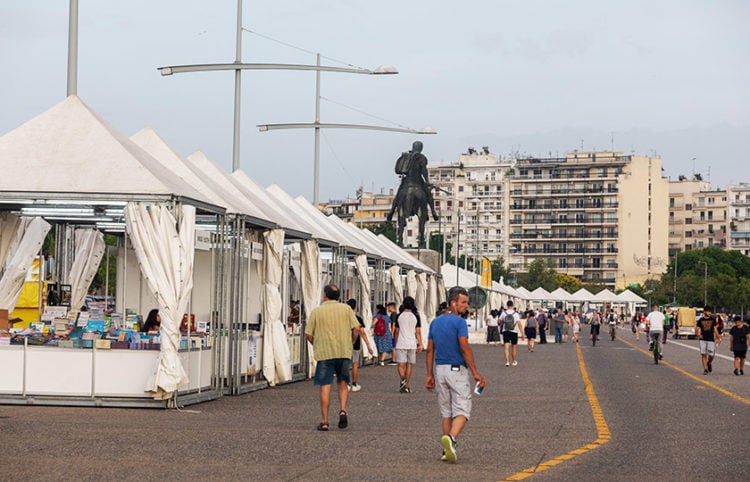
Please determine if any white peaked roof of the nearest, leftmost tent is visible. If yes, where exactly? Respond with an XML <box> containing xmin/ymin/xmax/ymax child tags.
<box><xmin>0</xmin><ymin>95</ymin><xmax>217</xmax><ymax>211</ymax></box>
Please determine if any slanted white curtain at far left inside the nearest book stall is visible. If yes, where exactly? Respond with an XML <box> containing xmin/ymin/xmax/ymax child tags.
<box><xmin>0</xmin><ymin>218</ymin><xmax>50</xmax><ymax>312</ymax></box>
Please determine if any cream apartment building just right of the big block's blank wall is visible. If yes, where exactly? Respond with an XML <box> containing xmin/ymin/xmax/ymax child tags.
<box><xmin>669</xmin><ymin>176</ymin><xmax>727</xmax><ymax>256</ymax></box>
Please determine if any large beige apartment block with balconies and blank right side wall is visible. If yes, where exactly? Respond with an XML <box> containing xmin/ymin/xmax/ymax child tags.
<box><xmin>506</xmin><ymin>151</ymin><xmax>669</xmax><ymax>289</ymax></box>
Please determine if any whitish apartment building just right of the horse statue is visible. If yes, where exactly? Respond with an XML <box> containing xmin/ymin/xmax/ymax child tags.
<box><xmin>426</xmin><ymin>147</ymin><xmax>515</xmax><ymax>260</ymax></box>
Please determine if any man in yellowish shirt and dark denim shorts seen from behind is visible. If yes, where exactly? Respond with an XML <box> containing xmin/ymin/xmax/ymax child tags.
<box><xmin>305</xmin><ymin>284</ymin><xmax>359</xmax><ymax>432</ymax></box>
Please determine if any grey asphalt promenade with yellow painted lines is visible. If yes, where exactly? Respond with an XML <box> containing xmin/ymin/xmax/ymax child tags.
<box><xmin>0</xmin><ymin>331</ymin><xmax>750</xmax><ymax>481</ymax></box>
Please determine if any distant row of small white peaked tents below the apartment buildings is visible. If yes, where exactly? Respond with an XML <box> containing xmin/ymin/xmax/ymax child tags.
<box><xmin>441</xmin><ymin>264</ymin><xmax>648</xmax><ymax>313</ymax></box>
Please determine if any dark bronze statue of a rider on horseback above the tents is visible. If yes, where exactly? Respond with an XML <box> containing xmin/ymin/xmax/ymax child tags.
<box><xmin>386</xmin><ymin>141</ymin><xmax>438</xmax><ymax>248</ymax></box>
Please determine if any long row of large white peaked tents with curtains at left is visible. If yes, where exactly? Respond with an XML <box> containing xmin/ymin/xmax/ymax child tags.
<box><xmin>0</xmin><ymin>96</ymin><xmax>445</xmax><ymax>401</ymax></box>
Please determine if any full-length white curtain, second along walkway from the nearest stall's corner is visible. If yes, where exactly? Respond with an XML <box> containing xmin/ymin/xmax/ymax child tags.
<box><xmin>263</xmin><ymin>229</ymin><xmax>292</xmax><ymax>386</ymax></box>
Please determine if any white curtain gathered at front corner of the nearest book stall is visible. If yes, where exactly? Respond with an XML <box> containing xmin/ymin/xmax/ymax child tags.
<box><xmin>125</xmin><ymin>203</ymin><xmax>195</xmax><ymax>400</ymax></box>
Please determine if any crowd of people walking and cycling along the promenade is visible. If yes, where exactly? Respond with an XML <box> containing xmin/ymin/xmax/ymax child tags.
<box><xmin>305</xmin><ymin>285</ymin><xmax>750</xmax><ymax>463</ymax></box>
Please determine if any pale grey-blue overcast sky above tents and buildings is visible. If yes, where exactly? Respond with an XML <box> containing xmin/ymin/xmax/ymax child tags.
<box><xmin>0</xmin><ymin>0</ymin><xmax>750</xmax><ymax>201</ymax></box>
